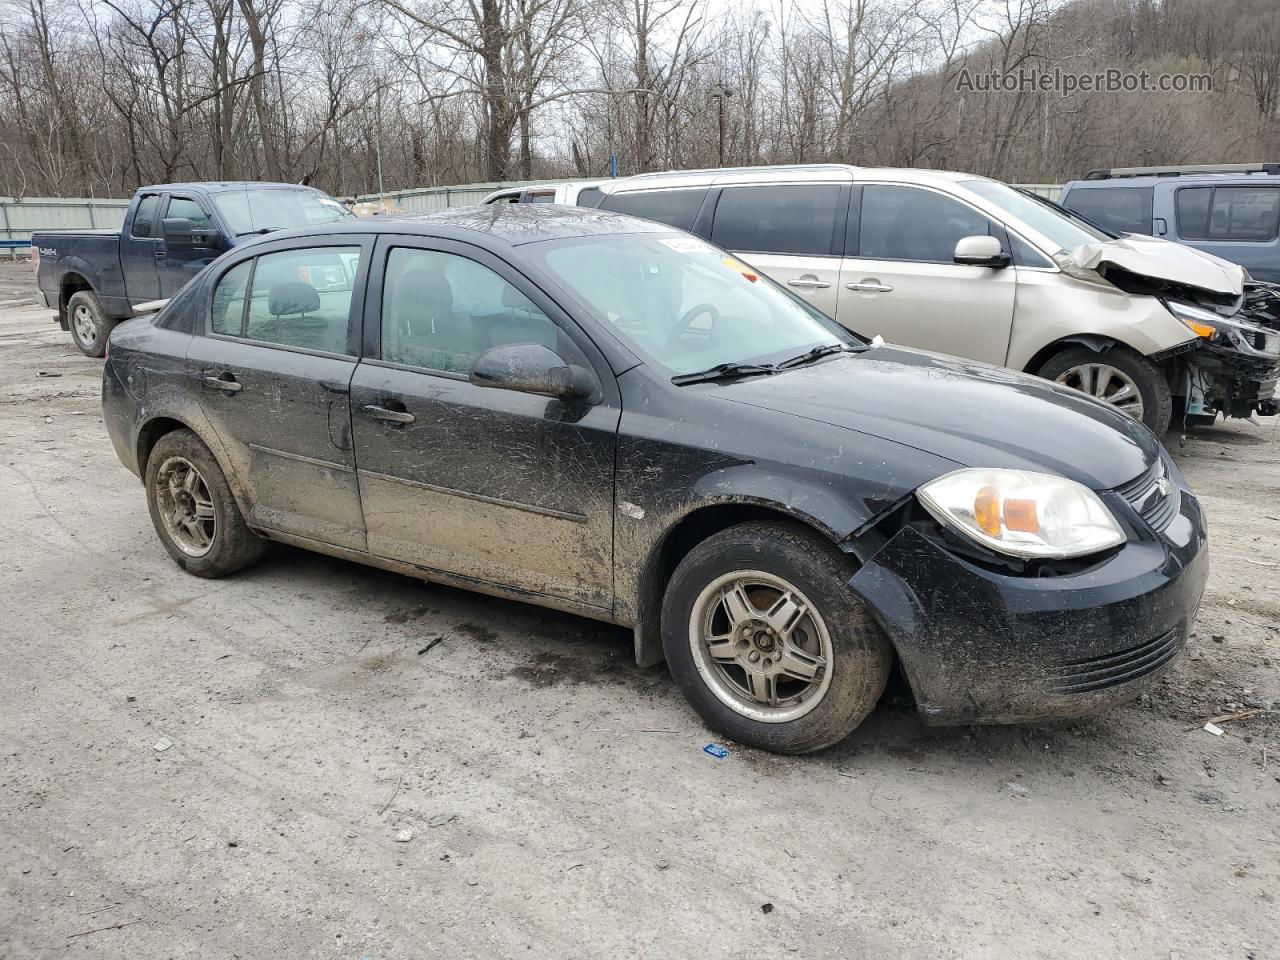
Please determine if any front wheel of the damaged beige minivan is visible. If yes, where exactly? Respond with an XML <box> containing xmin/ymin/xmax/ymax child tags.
<box><xmin>1039</xmin><ymin>346</ymin><xmax>1174</xmax><ymax>436</ymax></box>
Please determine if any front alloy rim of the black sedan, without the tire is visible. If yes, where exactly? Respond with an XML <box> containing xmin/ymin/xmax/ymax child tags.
<box><xmin>689</xmin><ymin>570</ymin><xmax>832</xmax><ymax>723</ymax></box>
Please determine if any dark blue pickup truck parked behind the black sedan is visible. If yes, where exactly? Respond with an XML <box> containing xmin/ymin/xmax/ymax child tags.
<box><xmin>31</xmin><ymin>182</ymin><xmax>352</xmax><ymax>357</ymax></box>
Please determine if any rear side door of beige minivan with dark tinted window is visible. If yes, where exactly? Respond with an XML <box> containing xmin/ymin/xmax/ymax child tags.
<box><xmin>710</xmin><ymin>183</ymin><xmax>849</xmax><ymax>317</ymax></box>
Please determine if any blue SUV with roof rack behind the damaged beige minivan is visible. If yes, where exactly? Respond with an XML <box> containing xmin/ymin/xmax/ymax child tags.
<box><xmin>1059</xmin><ymin>164</ymin><xmax>1280</xmax><ymax>283</ymax></box>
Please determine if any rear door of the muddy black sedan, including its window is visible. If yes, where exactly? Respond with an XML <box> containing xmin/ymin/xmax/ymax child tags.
<box><xmin>187</xmin><ymin>236</ymin><xmax>372</xmax><ymax>550</ymax></box>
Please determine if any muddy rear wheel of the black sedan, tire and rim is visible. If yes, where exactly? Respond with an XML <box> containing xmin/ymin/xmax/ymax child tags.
<box><xmin>146</xmin><ymin>430</ymin><xmax>266</xmax><ymax>577</ymax></box>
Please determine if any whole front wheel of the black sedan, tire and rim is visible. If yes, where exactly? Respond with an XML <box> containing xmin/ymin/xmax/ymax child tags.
<box><xmin>662</xmin><ymin>522</ymin><xmax>892</xmax><ymax>754</ymax></box>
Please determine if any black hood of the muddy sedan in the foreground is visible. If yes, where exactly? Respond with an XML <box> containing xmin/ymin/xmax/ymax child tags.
<box><xmin>712</xmin><ymin>346</ymin><xmax>1160</xmax><ymax>490</ymax></box>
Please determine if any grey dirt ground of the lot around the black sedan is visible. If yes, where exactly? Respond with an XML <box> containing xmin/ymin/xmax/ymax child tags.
<box><xmin>0</xmin><ymin>257</ymin><xmax>1280</xmax><ymax>960</ymax></box>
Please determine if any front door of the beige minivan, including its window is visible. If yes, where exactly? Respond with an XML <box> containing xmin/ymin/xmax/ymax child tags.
<box><xmin>836</xmin><ymin>183</ymin><xmax>1018</xmax><ymax>366</ymax></box>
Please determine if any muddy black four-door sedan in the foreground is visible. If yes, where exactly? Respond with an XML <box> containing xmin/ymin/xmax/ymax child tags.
<box><xmin>102</xmin><ymin>205</ymin><xmax>1207</xmax><ymax>753</ymax></box>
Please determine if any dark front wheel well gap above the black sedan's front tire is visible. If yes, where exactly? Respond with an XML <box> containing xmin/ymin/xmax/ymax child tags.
<box><xmin>635</xmin><ymin>503</ymin><xmax>826</xmax><ymax>667</ymax></box>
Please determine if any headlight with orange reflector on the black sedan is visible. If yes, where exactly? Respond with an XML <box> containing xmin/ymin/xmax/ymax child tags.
<box><xmin>916</xmin><ymin>468</ymin><xmax>1125</xmax><ymax>559</ymax></box>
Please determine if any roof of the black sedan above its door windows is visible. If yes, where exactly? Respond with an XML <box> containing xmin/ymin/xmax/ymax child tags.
<box><xmin>246</xmin><ymin>204</ymin><xmax>676</xmax><ymax>247</ymax></box>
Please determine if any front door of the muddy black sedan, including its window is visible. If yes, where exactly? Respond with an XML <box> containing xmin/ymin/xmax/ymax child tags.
<box><xmin>351</xmin><ymin>237</ymin><xmax>620</xmax><ymax>609</ymax></box>
